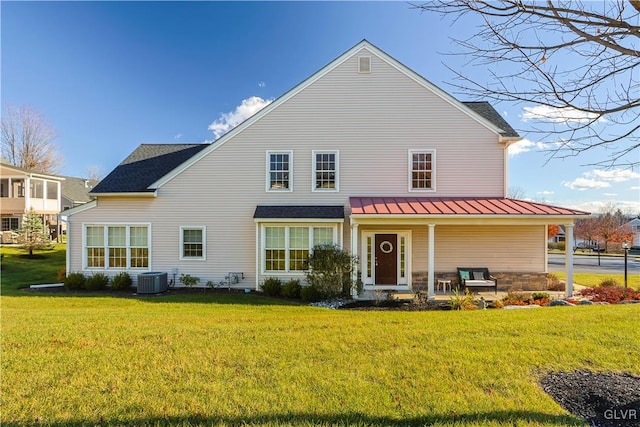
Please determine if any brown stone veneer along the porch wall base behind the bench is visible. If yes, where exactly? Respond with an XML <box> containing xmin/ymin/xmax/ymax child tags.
<box><xmin>412</xmin><ymin>270</ymin><xmax>549</xmax><ymax>292</ymax></box>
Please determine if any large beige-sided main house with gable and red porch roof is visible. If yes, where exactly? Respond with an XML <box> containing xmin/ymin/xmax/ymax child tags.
<box><xmin>65</xmin><ymin>41</ymin><xmax>588</xmax><ymax>296</ymax></box>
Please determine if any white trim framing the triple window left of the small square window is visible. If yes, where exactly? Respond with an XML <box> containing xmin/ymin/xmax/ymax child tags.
<box><xmin>82</xmin><ymin>222</ymin><xmax>153</xmax><ymax>272</ymax></box>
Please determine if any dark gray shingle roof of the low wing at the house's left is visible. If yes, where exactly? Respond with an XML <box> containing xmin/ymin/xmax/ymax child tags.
<box><xmin>91</xmin><ymin>144</ymin><xmax>209</xmax><ymax>194</ymax></box>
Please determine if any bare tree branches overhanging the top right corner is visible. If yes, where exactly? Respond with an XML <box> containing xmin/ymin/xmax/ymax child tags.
<box><xmin>412</xmin><ymin>0</ymin><xmax>640</xmax><ymax>167</ymax></box>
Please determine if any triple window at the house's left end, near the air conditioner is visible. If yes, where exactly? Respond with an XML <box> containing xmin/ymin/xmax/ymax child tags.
<box><xmin>84</xmin><ymin>224</ymin><xmax>149</xmax><ymax>270</ymax></box>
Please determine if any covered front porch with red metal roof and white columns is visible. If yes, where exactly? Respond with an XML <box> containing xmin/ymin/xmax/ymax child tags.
<box><xmin>349</xmin><ymin>197</ymin><xmax>589</xmax><ymax>299</ymax></box>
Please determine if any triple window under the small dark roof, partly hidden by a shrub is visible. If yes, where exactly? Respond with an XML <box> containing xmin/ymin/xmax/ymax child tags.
<box><xmin>263</xmin><ymin>225</ymin><xmax>337</xmax><ymax>272</ymax></box>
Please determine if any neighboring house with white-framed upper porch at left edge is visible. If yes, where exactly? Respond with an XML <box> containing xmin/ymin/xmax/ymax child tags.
<box><xmin>0</xmin><ymin>162</ymin><xmax>64</xmax><ymax>243</ymax></box>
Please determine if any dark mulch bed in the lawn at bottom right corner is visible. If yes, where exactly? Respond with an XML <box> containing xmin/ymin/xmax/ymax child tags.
<box><xmin>541</xmin><ymin>371</ymin><xmax>640</xmax><ymax>427</ymax></box>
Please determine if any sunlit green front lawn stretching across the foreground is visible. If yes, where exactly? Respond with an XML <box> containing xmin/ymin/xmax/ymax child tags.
<box><xmin>2</xmin><ymin>294</ymin><xmax>640</xmax><ymax>426</ymax></box>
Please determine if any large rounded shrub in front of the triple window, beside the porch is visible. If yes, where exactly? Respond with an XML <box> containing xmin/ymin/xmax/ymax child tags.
<box><xmin>305</xmin><ymin>245</ymin><xmax>356</xmax><ymax>299</ymax></box>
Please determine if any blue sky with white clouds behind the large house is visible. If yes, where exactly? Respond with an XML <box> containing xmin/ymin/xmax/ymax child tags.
<box><xmin>0</xmin><ymin>1</ymin><xmax>640</xmax><ymax>214</ymax></box>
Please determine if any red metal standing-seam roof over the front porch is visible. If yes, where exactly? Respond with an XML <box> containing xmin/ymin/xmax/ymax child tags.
<box><xmin>349</xmin><ymin>197</ymin><xmax>589</xmax><ymax>215</ymax></box>
